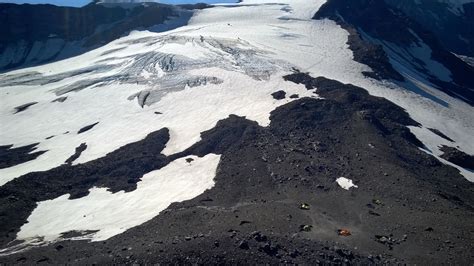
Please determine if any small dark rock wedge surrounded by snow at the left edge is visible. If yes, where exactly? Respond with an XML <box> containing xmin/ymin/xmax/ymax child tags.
<box><xmin>0</xmin><ymin>143</ymin><xmax>47</xmax><ymax>169</ymax></box>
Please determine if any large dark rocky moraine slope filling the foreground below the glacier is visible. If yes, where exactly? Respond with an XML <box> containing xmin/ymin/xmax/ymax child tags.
<box><xmin>0</xmin><ymin>73</ymin><xmax>474</xmax><ymax>264</ymax></box>
